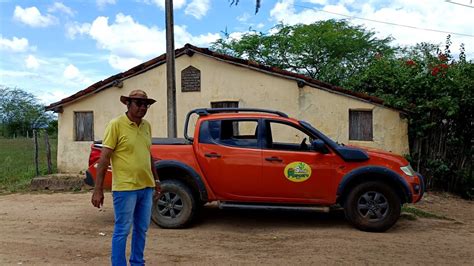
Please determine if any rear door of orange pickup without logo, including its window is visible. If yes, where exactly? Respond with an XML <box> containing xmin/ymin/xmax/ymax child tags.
<box><xmin>196</xmin><ymin>119</ymin><xmax>262</xmax><ymax>201</ymax></box>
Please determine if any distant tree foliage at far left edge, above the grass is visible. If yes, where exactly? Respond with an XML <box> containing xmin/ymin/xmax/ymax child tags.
<box><xmin>0</xmin><ymin>87</ymin><xmax>54</xmax><ymax>137</ymax></box>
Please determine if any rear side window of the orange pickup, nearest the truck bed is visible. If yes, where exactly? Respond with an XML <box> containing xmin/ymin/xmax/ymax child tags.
<box><xmin>209</xmin><ymin>120</ymin><xmax>258</xmax><ymax>148</ymax></box>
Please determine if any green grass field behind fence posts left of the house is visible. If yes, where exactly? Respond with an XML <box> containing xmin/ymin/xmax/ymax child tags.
<box><xmin>0</xmin><ymin>134</ymin><xmax>58</xmax><ymax>192</ymax></box>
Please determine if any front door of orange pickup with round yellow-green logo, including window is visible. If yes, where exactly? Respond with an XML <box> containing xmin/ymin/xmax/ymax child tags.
<box><xmin>260</xmin><ymin>120</ymin><xmax>337</xmax><ymax>202</ymax></box>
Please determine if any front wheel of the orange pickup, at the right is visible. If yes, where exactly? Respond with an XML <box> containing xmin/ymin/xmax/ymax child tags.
<box><xmin>344</xmin><ymin>182</ymin><xmax>401</xmax><ymax>232</ymax></box>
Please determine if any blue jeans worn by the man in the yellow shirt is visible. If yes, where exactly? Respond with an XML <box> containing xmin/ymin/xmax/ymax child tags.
<box><xmin>111</xmin><ymin>188</ymin><xmax>154</xmax><ymax>266</ymax></box>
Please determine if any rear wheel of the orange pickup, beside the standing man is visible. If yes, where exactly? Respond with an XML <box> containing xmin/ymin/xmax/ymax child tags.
<box><xmin>151</xmin><ymin>180</ymin><xmax>196</xmax><ymax>229</ymax></box>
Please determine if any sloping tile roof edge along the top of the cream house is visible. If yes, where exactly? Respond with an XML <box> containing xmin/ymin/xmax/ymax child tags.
<box><xmin>46</xmin><ymin>44</ymin><xmax>406</xmax><ymax>113</ymax></box>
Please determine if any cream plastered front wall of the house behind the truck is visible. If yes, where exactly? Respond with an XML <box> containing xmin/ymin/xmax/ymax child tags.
<box><xmin>58</xmin><ymin>54</ymin><xmax>408</xmax><ymax>172</ymax></box>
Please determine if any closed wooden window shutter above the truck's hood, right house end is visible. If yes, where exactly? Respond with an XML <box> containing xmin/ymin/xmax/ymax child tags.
<box><xmin>349</xmin><ymin>110</ymin><xmax>373</xmax><ymax>141</ymax></box>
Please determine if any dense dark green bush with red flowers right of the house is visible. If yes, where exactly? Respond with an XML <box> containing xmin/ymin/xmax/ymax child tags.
<box><xmin>351</xmin><ymin>36</ymin><xmax>474</xmax><ymax>197</ymax></box>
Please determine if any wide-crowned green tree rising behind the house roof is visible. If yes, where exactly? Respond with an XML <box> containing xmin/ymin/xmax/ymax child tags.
<box><xmin>211</xmin><ymin>20</ymin><xmax>394</xmax><ymax>86</ymax></box>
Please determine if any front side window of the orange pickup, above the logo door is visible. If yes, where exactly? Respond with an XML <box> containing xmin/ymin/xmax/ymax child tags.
<box><xmin>266</xmin><ymin>121</ymin><xmax>314</xmax><ymax>151</ymax></box>
